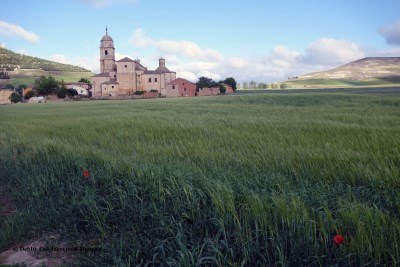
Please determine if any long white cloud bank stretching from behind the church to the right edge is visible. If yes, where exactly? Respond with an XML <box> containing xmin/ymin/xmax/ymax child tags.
<box><xmin>129</xmin><ymin>28</ymin><xmax>400</xmax><ymax>82</ymax></box>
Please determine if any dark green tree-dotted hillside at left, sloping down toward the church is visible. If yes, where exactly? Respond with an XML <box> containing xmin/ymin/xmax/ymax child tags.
<box><xmin>0</xmin><ymin>47</ymin><xmax>90</xmax><ymax>72</ymax></box>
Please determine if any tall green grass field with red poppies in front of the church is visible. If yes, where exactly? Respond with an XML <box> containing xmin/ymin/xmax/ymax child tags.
<box><xmin>0</xmin><ymin>94</ymin><xmax>400</xmax><ymax>266</ymax></box>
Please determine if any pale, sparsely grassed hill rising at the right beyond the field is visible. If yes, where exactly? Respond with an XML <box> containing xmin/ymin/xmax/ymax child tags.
<box><xmin>284</xmin><ymin>57</ymin><xmax>400</xmax><ymax>88</ymax></box>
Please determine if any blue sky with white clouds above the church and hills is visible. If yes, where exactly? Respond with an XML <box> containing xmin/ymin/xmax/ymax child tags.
<box><xmin>0</xmin><ymin>0</ymin><xmax>400</xmax><ymax>82</ymax></box>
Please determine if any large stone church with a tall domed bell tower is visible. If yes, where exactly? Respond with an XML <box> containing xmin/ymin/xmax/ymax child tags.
<box><xmin>91</xmin><ymin>29</ymin><xmax>176</xmax><ymax>98</ymax></box>
